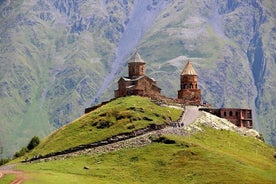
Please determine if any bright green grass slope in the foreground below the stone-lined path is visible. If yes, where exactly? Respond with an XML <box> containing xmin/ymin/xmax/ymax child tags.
<box><xmin>18</xmin><ymin>128</ymin><xmax>276</xmax><ymax>184</ymax></box>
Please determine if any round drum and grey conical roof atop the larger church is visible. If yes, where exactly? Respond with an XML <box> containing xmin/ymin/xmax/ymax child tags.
<box><xmin>128</xmin><ymin>51</ymin><xmax>146</xmax><ymax>79</ymax></box>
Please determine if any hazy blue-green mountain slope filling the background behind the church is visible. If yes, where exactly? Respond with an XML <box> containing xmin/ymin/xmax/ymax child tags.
<box><xmin>0</xmin><ymin>0</ymin><xmax>276</xmax><ymax>156</ymax></box>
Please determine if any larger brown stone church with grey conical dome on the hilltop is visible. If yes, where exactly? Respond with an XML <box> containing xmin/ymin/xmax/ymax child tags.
<box><xmin>114</xmin><ymin>52</ymin><xmax>161</xmax><ymax>98</ymax></box>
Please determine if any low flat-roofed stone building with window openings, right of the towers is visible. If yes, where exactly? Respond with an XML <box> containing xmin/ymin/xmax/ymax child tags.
<box><xmin>200</xmin><ymin>108</ymin><xmax>253</xmax><ymax>128</ymax></box>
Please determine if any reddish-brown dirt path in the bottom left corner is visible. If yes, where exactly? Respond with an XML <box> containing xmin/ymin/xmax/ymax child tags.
<box><xmin>0</xmin><ymin>165</ymin><xmax>26</xmax><ymax>184</ymax></box>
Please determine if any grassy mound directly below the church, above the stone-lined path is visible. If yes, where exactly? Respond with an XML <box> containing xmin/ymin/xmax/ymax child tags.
<box><xmin>24</xmin><ymin>96</ymin><xmax>182</xmax><ymax>156</ymax></box>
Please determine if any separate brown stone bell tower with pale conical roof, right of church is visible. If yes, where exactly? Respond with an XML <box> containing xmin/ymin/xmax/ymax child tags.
<box><xmin>178</xmin><ymin>61</ymin><xmax>201</xmax><ymax>105</ymax></box>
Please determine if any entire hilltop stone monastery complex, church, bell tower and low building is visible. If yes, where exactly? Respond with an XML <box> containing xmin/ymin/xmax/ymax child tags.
<box><xmin>85</xmin><ymin>52</ymin><xmax>253</xmax><ymax>128</ymax></box>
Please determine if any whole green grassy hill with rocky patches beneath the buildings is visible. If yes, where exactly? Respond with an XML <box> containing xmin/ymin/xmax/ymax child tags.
<box><xmin>7</xmin><ymin>96</ymin><xmax>276</xmax><ymax>183</ymax></box>
